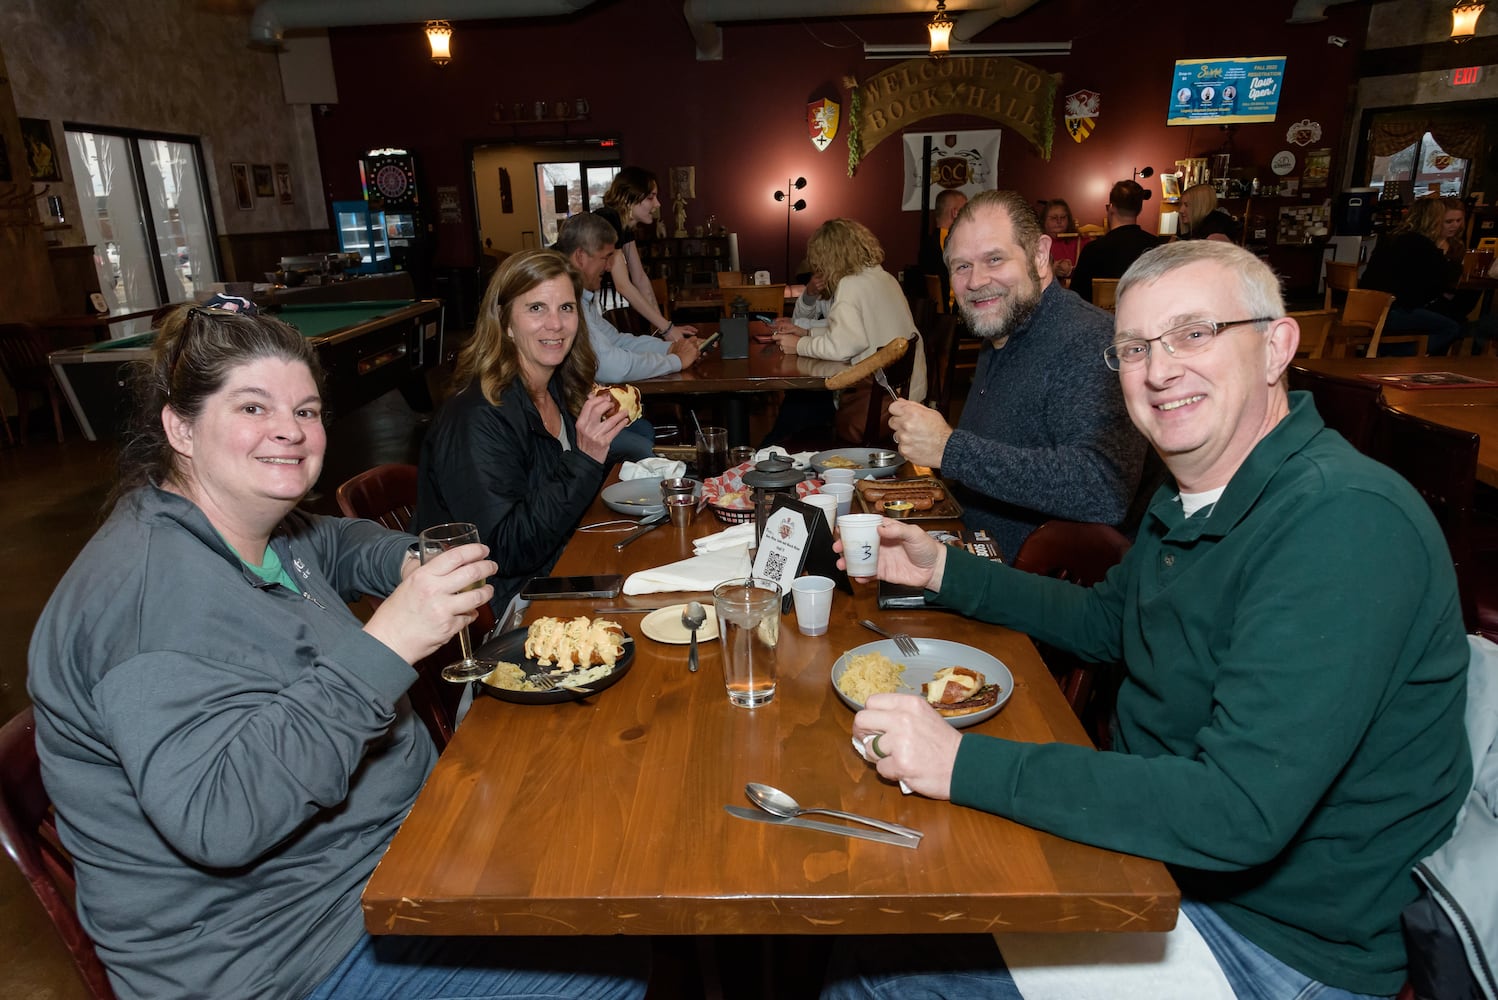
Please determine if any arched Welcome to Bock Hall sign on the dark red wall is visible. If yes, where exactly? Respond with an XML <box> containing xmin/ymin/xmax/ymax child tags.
<box><xmin>848</xmin><ymin>55</ymin><xmax>1056</xmax><ymax>172</ymax></box>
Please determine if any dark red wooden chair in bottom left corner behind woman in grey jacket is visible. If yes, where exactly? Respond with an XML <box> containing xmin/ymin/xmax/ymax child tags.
<box><xmin>0</xmin><ymin>705</ymin><xmax>114</xmax><ymax>1000</ymax></box>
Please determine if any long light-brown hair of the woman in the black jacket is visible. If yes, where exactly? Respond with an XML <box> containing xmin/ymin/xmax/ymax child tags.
<box><xmin>452</xmin><ymin>250</ymin><xmax>598</xmax><ymax>416</ymax></box>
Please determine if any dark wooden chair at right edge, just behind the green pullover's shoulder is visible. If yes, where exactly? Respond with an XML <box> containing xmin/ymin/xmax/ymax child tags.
<box><xmin>1368</xmin><ymin>400</ymin><xmax>1498</xmax><ymax>639</ymax></box>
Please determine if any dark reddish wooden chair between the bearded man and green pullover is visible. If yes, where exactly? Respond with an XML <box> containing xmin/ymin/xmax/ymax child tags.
<box><xmin>1010</xmin><ymin>519</ymin><xmax>1129</xmax><ymax>749</ymax></box>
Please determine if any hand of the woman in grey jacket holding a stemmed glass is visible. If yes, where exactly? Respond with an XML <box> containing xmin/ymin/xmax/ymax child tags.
<box><xmin>364</xmin><ymin>530</ymin><xmax>499</xmax><ymax>677</ymax></box>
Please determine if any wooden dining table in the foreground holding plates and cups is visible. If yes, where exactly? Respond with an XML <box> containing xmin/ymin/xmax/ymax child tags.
<box><xmin>363</xmin><ymin>479</ymin><xmax>1179</xmax><ymax>936</ymax></box>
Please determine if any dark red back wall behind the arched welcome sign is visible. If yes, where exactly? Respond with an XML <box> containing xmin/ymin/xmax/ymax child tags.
<box><xmin>316</xmin><ymin>0</ymin><xmax>1368</xmax><ymax>273</ymax></box>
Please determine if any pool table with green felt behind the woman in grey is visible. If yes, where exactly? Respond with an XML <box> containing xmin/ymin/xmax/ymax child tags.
<box><xmin>48</xmin><ymin>299</ymin><xmax>443</xmax><ymax>440</ymax></box>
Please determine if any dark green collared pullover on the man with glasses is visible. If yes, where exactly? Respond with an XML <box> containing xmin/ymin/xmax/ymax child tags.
<box><xmin>935</xmin><ymin>392</ymin><xmax>1471</xmax><ymax>994</ymax></box>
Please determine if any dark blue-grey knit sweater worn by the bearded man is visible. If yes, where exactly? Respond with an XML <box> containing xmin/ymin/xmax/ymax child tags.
<box><xmin>941</xmin><ymin>283</ymin><xmax>1144</xmax><ymax>558</ymax></box>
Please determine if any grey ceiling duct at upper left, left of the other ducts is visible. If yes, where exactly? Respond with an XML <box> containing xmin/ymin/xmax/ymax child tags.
<box><xmin>250</xmin><ymin>0</ymin><xmax>593</xmax><ymax>45</ymax></box>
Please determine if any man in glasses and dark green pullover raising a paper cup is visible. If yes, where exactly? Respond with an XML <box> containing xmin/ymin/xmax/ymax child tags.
<box><xmin>825</xmin><ymin>241</ymin><xmax>1471</xmax><ymax>1000</ymax></box>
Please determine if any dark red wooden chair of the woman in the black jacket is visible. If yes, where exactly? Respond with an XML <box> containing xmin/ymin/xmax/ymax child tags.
<box><xmin>337</xmin><ymin>464</ymin><xmax>494</xmax><ymax>751</ymax></box>
